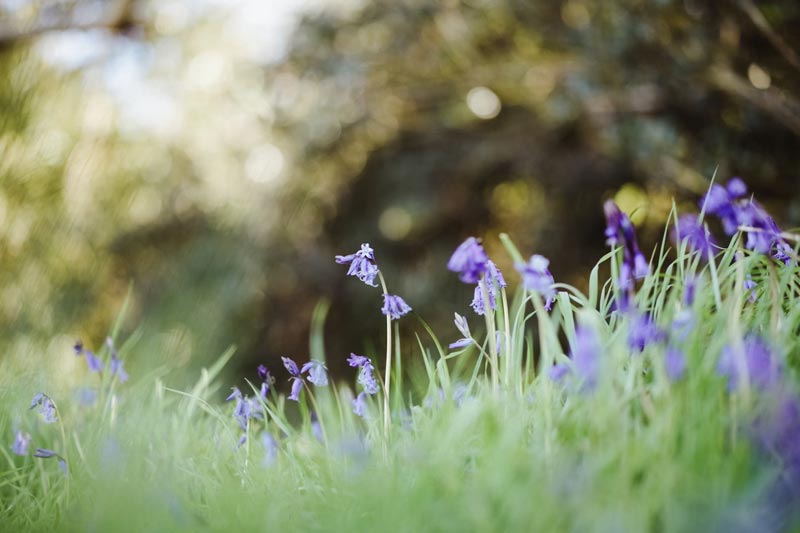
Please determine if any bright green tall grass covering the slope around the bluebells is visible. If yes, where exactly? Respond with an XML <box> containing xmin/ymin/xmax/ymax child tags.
<box><xmin>0</xmin><ymin>193</ymin><xmax>800</xmax><ymax>531</ymax></box>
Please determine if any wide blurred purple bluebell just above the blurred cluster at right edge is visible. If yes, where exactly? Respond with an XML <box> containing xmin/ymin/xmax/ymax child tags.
<box><xmin>717</xmin><ymin>335</ymin><xmax>781</xmax><ymax>391</ymax></box>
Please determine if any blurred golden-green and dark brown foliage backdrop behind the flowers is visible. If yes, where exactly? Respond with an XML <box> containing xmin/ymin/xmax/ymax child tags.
<box><xmin>0</xmin><ymin>0</ymin><xmax>800</xmax><ymax>379</ymax></box>
